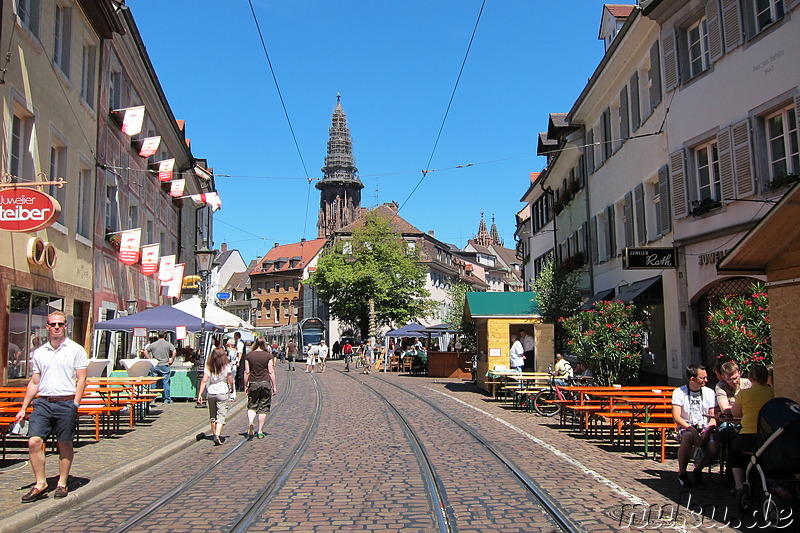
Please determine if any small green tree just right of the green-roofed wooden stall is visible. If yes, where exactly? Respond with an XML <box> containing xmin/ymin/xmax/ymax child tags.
<box><xmin>533</xmin><ymin>257</ymin><xmax>581</xmax><ymax>351</ymax></box>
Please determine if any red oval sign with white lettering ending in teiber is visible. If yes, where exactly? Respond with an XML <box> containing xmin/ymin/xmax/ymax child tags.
<box><xmin>0</xmin><ymin>187</ymin><xmax>61</xmax><ymax>232</ymax></box>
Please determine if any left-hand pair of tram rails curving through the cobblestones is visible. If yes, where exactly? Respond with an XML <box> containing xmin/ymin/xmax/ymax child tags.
<box><xmin>112</xmin><ymin>366</ymin><xmax>322</xmax><ymax>533</ymax></box>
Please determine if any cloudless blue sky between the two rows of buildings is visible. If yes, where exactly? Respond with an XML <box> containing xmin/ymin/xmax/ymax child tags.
<box><xmin>126</xmin><ymin>0</ymin><xmax>616</xmax><ymax>261</ymax></box>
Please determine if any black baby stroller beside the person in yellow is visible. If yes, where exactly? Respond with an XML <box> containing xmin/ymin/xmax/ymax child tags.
<box><xmin>738</xmin><ymin>398</ymin><xmax>800</xmax><ymax>525</ymax></box>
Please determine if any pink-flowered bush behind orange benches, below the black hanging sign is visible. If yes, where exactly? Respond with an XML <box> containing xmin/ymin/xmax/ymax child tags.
<box><xmin>559</xmin><ymin>300</ymin><xmax>646</xmax><ymax>386</ymax></box>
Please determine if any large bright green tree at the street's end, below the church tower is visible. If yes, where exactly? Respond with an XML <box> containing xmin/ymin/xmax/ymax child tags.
<box><xmin>304</xmin><ymin>211</ymin><xmax>432</xmax><ymax>338</ymax></box>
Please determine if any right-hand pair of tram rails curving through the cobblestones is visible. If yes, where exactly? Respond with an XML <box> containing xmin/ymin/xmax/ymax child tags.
<box><xmin>349</xmin><ymin>375</ymin><xmax>583</xmax><ymax>533</ymax></box>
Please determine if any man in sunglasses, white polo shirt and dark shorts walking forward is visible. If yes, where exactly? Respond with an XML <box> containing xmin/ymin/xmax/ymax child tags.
<box><xmin>16</xmin><ymin>311</ymin><xmax>88</xmax><ymax>503</ymax></box>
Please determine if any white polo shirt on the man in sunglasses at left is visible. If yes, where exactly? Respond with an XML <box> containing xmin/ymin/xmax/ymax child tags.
<box><xmin>31</xmin><ymin>339</ymin><xmax>89</xmax><ymax>396</ymax></box>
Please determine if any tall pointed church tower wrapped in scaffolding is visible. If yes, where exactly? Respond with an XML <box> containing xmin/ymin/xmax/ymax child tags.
<box><xmin>315</xmin><ymin>95</ymin><xmax>364</xmax><ymax>238</ymax></box>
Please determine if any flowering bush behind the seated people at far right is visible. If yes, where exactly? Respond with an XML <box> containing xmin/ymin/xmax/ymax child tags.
<box><xmin>706</xmin><ymin>283</ymin><xmax>772</xmax><ymax>372</ymax></box>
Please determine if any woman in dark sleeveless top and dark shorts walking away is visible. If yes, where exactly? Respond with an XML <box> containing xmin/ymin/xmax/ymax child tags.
<box><xmin>244</xmin><ymin>337</ymin><xmax>278</xmax><ymax>439</ymax></box>
